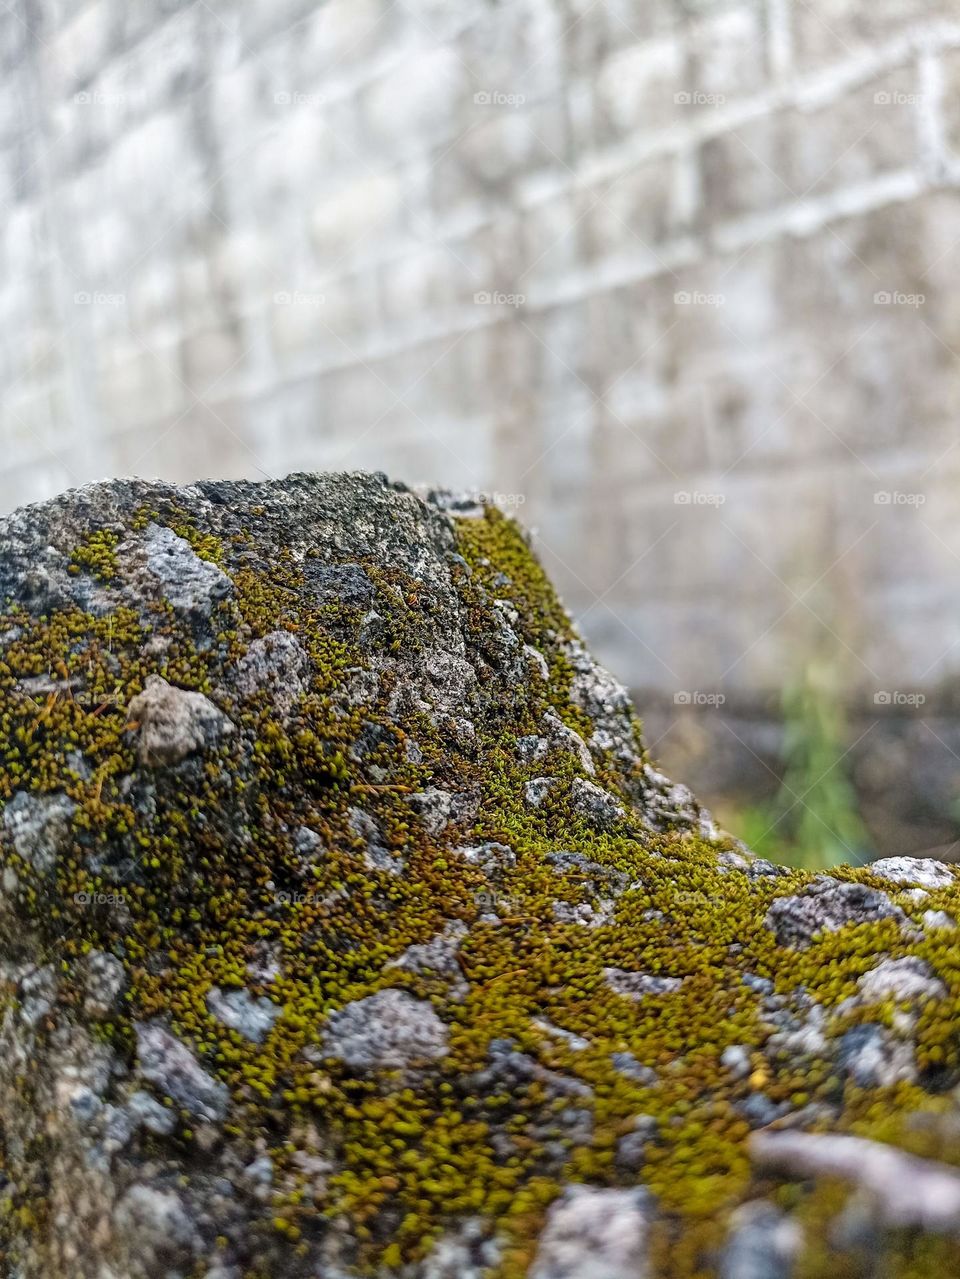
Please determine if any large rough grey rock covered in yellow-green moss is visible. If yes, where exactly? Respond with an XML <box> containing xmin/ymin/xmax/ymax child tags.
<box><xmin>0</xmin><ymin>475</ymin><xmax>960</xmax><ymax>1279</ymax></box>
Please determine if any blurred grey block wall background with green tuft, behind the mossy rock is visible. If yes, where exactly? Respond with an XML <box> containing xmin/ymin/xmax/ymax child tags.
<box><xmin>0</xmin><ymin>0</ymin><xmax>960</xmax><ymax>862</ymax></box>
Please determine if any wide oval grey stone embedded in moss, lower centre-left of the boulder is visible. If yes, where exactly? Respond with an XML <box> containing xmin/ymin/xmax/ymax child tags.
<box><xmin>323</xmin><ymin>990</ymin><xmax>447</xmax><ymax>1073</ymax></box>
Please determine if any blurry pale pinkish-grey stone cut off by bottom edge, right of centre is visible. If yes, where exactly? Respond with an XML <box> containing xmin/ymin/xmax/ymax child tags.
<box><xmin>529</xmin><ymin>1186</ymin><xmax>651</xmax><ymax>1279</ymax></box>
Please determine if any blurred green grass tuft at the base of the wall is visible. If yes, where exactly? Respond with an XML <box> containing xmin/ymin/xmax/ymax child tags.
<box><xmin>730</xmin><ymin>663</ymin><xmax>873</xmax><ymax>870</ymax></box>
